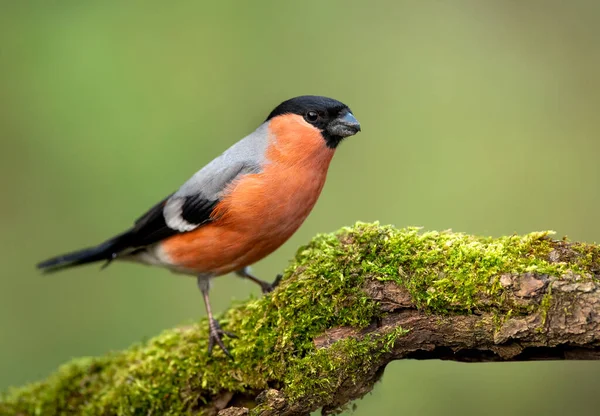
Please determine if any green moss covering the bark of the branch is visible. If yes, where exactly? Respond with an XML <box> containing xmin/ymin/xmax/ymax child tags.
<box><xmin>0</xmin><ymin>224</ymin><xmax>598</xmax><ymax>415</ymax></box>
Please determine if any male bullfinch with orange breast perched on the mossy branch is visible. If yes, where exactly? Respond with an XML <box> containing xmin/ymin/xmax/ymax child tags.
<box><xmin>38</xmin><ymin>95</ymin><xmax>360</xmax><ymax>355</ymax></box>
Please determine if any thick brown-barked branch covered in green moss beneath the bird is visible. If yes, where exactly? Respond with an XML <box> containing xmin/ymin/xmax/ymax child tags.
<box><xmin>0</xmin><ymin>224</ymin><xmax>600</xmax><ymax>415</ymax></box>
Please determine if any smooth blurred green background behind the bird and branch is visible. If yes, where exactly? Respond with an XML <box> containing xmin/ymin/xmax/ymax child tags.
<box><xmin>0</xmin><ymin>0</ymin><xmax>600</xmax><ymax>415</ymax></box>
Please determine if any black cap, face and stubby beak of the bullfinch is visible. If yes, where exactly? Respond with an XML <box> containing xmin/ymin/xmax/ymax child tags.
<box><xmin>266</xmin><ymin>95</ymin><xmax>360</xmax><ymax>148</ymax></box>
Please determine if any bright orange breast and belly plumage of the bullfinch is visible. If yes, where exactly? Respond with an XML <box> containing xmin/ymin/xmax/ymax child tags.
<box><xmin>161</xmin><ymin>115</ymin><xmax>333</xmax><ymax>275</ymax></box>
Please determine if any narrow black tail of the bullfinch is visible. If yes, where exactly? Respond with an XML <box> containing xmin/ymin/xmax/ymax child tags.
<box><xmin>37</xmin><ymin>233</ymin><xmax>127</xmax><ymax>273</ymax></box>
